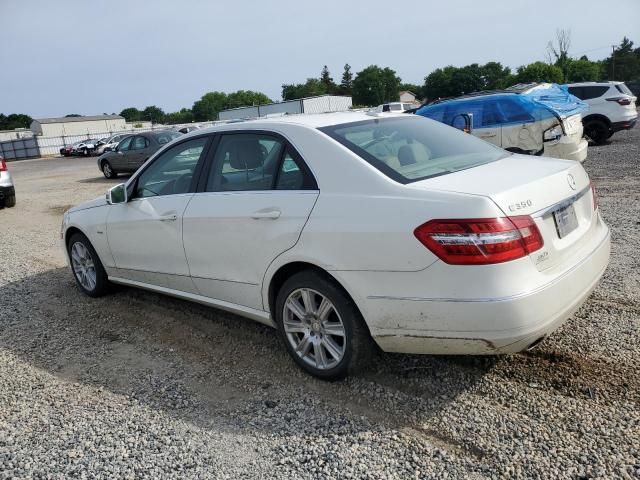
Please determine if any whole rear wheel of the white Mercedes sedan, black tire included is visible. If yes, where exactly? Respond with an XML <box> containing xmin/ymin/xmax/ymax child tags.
<box><xmin>275</xmin><ymin>270</ymin><xmax>374</xmax><ymax>380</ymax></box>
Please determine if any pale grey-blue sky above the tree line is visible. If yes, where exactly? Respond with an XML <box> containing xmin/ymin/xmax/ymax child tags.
<box><xmin>0</xmin><ymin>0</ymin><xmax>640</xmax><ymax>117</ymax></box>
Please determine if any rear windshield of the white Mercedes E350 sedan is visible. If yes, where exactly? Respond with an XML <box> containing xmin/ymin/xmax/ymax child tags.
<box><xmin>320</xmin><ymin>115</ymin><xmax>510</xmax><ymax>184</ymax></box>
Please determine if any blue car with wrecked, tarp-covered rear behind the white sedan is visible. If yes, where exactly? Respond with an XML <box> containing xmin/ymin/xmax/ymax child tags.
<box><xmin>416</xmin><ymin>84</ymin><xmax>587</xmax><ymax>162</ymax></box>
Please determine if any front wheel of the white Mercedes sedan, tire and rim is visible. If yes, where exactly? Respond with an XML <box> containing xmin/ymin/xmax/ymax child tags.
<box><xmin>67</xmin><ymin>233</ymin><xmax>109</xmax><ymax>297</ymax></box>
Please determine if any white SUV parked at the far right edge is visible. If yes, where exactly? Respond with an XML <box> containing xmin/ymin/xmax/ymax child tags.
<box><xmin>565</xmin><ymin>82</ymin><xmax>638</xmax><ymax>144</ymax></box>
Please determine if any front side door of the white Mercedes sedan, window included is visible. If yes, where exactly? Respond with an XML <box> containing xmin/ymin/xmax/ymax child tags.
<box><xmin>107</xmin><ymin>137</ymin><xmax>208</xmax><ymax>292</ymax></box>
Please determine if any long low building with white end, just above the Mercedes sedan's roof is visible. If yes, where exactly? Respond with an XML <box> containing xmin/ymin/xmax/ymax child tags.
<box><xmin>218</xmin><ymin>95</ymin><xmax>353</xmax><ymax>120</ymax></box>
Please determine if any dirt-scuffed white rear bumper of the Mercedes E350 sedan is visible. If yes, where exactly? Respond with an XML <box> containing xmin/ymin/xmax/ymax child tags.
<box><xmin>336</xmin><ymin>216</ymin><xmax>610</xmax><ymax>355</ymax></box>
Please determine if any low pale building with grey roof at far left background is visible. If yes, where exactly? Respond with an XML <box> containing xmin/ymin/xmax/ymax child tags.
<box><xmin>31</xmin><ymin>115</ymin><xmax>127</xmax><ymax>137</ymax></box>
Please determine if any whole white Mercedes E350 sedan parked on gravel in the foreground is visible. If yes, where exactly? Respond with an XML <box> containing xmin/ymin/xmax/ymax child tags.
<box><xmin>62</xmin><ymin>112</ymin><xmax>610</xmax><ymax>379</ymax></box>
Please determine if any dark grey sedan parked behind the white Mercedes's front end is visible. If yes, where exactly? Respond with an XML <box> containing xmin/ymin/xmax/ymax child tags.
<box><xmin>98</xmin><ymin>130</ymin><xmax>182</xmax><ymax>178</ymax></box>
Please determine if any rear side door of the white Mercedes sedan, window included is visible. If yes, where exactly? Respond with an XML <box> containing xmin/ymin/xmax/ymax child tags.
<box><xmin>183</xmin><ymin>131</ymin><xmax>319</xmax><ymax>310</ymax></box>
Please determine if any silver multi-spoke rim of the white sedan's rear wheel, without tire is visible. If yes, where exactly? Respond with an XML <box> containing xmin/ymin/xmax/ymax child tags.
<box><xmin>282</xmin><ymin>288</ymin><xmax>347</xmax><ymax>370</ymax></box>
